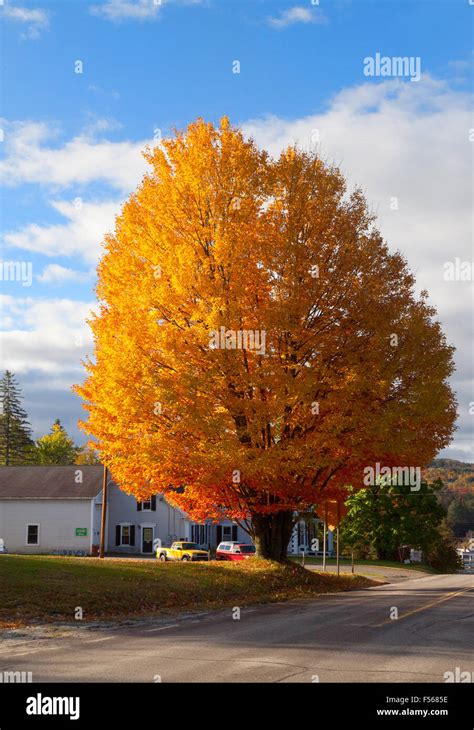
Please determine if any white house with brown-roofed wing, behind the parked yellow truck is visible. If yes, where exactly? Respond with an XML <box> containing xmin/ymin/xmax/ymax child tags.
<box><xmin>0</xmin><ymin>465</ymin><xmax>249</xmax><ymax>555</ymax></box>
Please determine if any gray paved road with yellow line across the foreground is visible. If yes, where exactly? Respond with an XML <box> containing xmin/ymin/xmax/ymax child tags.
<box><xmin>0</xmin><ymin>574</ymin><xmax>474</xmax><ymax>682</ymax></box>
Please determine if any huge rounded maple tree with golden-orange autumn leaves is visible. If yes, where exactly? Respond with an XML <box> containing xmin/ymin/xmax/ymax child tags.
<box><xmin>76</xmin><ymin>119</ymin><xmax>455</xmax><ymax>560</ymax></box>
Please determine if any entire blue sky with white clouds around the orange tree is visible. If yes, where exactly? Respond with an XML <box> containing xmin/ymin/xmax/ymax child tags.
<box><xmin>0</xmin><ymin>0</ymin><xmax>474</xmax><ymax>461</ymax></box>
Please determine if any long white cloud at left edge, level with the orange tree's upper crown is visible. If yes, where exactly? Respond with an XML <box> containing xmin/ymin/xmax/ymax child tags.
<box><xmin>0</xmin><ymin>121</ymin><xmax>147</xmax><ymax>192</ymax></box>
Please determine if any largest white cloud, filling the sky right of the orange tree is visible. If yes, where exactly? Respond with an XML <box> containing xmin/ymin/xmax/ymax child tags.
<box><xmin>242</xmin><ymin>75</ymin><xmax>474</xmax><ymax>461</ymax></box>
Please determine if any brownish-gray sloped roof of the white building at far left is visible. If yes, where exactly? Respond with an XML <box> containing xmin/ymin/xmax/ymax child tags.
<box><xmin>0</xmin><ymin>464</ymin><xmax>103</xmax><ymax>499</ymax></box>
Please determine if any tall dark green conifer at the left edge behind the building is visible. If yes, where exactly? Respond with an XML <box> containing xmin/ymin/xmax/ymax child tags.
<box><xmin>0</xmin><ymin>370</ymin><xmax>34</xmax><ymax>466</ymax></box>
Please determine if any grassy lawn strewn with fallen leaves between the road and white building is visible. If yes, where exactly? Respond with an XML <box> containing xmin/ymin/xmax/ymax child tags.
<box><xmin>0</xmin><ymin>555</ymin><xmax>374</xmax><ymax>627</ymax></box>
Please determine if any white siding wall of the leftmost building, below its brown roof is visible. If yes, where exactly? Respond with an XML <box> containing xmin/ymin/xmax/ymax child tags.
<box><xmin>0</xmin><ymin>499</ymin><xmax>95</xmax><ymax>553</ymax></box>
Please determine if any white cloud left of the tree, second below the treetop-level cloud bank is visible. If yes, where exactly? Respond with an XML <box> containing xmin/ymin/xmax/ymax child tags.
<box><xmin>4</xmin><ymin>200</ymin><xmax>120</xmax><ymax>268</ymax></box>
